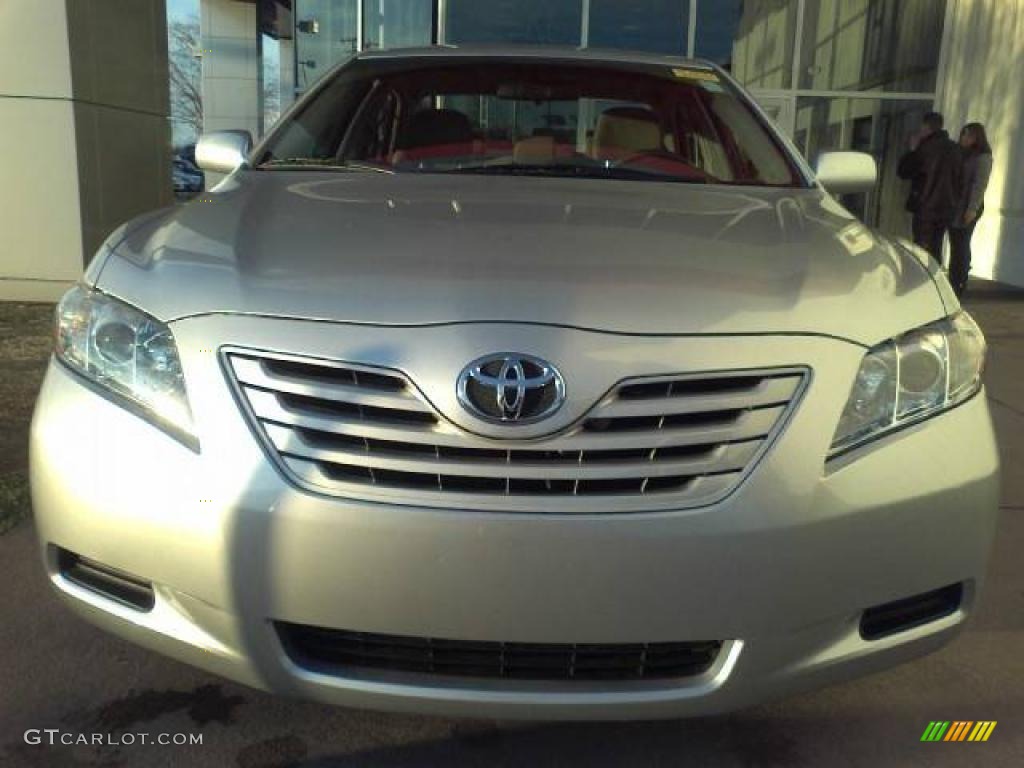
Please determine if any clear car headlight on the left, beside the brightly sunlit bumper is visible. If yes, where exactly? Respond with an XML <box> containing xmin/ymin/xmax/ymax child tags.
<box><xmin>54</xmin><ymin>286</ymin><xmax>196</xmax><ymax>447</ymax></box>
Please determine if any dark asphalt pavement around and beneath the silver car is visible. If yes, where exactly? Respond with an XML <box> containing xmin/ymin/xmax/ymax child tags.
<box><xmin>0</xmin><ymin>285</ymin><xmax>1024</xmax><ymax>768</ymax></box>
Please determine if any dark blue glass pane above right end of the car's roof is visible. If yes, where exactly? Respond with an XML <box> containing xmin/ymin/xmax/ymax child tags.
<box><xmin>587</xmin><ymin>0</ymin><xmax>690</xmax><ymax>55</ymax></box>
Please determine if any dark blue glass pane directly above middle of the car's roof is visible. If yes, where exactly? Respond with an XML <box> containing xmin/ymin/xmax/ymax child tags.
<box><xmin>444</xmin><ymin>0</ymin><xmax>583</xmax><ymax>45</ymax></box>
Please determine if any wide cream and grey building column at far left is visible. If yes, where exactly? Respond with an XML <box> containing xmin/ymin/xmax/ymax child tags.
<box><xmin>0</xmin><ymin>0</ymin><xmax>172</xmax><ymax>300</ymax></box>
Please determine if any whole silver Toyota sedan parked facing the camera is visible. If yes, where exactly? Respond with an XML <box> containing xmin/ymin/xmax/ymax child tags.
<box><xmin>32</xmin><ymin>49</ymin><xmax>998</xmax><ymax>719</ymax></box>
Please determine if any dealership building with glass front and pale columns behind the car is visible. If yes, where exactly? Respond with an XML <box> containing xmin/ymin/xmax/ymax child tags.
<box><xmin>0</xmin><ymin>0</ymin><xmax>1024</xmax><ymax>300</ymax></box>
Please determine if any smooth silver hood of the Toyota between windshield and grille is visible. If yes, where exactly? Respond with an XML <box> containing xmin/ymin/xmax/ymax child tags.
<box><xmin>97</xmin><ymin>171</ymin><xmax>945</xmax><ymax>344</ymax></box>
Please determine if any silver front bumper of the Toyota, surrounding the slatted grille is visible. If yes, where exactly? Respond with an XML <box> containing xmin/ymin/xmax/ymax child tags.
<box><xmin>32</xmin><ymin>317</ymin><xmax>998</xmax><ymax>719</ymax></box>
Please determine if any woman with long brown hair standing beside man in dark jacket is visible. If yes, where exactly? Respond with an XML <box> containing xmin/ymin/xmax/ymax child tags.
<box><xmin>949</xmin><ymin>123</ymin><xmax>992</xmax><ymax>296</ymax></box>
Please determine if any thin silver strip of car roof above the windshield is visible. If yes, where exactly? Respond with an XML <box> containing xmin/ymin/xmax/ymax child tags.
<box><xmin>356</xmin><ymin>45</ymin><xmax>718</xmax><ymax>71</ymax></box>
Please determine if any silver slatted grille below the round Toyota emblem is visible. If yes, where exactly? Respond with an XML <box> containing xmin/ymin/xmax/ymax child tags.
<box><xmin>226</xmin><ymin>350</ymin><xmax>804</xmax><ymax>512</ymax></box>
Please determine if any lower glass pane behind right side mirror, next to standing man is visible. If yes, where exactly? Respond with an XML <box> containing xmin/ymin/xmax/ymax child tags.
<box><xmin>795</xmin><ymin>97</ymin><xmax>932</xmax><ymax>237</ymax></box>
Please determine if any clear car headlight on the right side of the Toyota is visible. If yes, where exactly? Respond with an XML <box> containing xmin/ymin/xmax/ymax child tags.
<box><xmin>829</xmin><ymin>312</ymin><xmax>985</xmax><ymax>456</ymax></box>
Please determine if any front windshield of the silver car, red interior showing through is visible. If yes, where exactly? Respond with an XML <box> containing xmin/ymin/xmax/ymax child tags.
<box><xmin>256</xmin><ymin>57</ymin><xmax>802</xmax><ymax>186</ymax></box>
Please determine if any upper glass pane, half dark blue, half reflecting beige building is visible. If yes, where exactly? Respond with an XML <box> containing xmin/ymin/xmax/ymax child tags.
<box><xmin>720</xmin><ymin>0</ymin><xmax>799</xmax><ymax>88</ymax></box>
